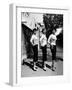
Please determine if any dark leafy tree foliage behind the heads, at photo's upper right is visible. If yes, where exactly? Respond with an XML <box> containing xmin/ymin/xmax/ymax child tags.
<box><xmin>43</xmin><ymin>14</ymin><xmax>63</xmax><ymax>38</ymax></box>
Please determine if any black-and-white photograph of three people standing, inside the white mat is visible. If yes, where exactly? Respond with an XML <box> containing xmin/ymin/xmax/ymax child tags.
<box><xmin>21</xmin><ymin>12</ymin><xmax>63</xmax><ymax>77</ymax></box>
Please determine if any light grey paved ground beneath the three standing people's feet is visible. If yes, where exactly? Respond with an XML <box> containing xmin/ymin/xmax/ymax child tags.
<box><xmin>21</xmin><ymin>47</ymin><xmax>63</xmax><ymax>77</ymax></box>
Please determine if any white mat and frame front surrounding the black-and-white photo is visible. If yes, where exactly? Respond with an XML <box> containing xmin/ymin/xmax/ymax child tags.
<box><xmin>13</xmin><ymin>4</ymin><xmax>70</xmax><ymax>85</ymax></box>
